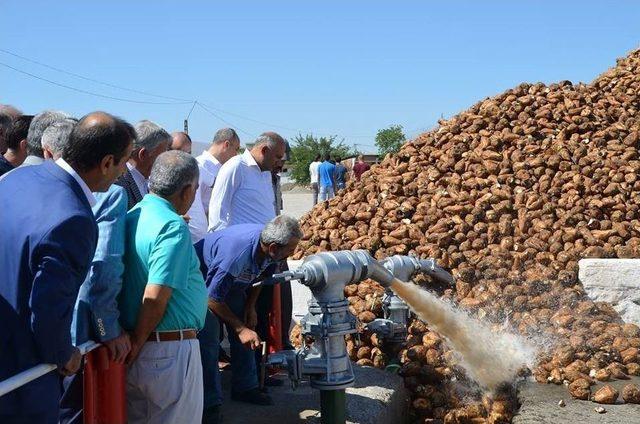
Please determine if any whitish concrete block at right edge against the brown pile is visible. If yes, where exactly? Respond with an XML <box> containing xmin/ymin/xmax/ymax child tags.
<box><xmin>578</xmin><ymin>259</ymin><xmax>640</xmax><ymax>325</ymax></box>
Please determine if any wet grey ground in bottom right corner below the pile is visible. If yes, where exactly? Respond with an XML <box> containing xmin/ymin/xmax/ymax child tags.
<box><xmin>513</xmin><ymin>377</ymin><xmax>640</xmax><ymax>424</ymax></box>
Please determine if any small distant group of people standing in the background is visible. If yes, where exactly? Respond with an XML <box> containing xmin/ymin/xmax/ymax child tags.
<box><xmin>309</xmin><ymin>153</ymin><xmax>370</xmax><ymax>205</ymax></box>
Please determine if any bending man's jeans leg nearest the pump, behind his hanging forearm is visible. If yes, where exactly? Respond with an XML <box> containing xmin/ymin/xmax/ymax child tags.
<box><xmin>225</xmin><ymin>288</ymin><xmax>258</xmax><ymax>393</ymax></box>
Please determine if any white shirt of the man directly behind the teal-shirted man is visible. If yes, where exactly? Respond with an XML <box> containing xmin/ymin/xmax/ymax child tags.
<box><xmin>187</xmin><ymin>150</ymin><xmax>222</xmax><ymax>243</ymax></box>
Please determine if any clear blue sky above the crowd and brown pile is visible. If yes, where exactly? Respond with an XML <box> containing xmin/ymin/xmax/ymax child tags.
<box><xmin>0</xmin><ymin>0</ymin><xmax>640</xmax><ymax>150</ymax></box>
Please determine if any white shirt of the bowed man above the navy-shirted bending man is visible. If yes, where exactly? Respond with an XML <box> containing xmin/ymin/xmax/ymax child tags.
<box><xmin>209</xmin><ymin>149</ymin><xmax>275</xmax><ymax>231</ymax></box>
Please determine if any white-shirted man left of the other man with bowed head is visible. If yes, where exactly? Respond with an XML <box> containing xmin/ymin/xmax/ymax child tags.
<box><xmin>187</xmin><ymin>128</ymin><xmax>240</xmax><ymax>244</ymax></box>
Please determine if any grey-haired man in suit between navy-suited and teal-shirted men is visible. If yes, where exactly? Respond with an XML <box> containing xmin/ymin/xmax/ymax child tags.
<box><xmin>116</xmin><ymin>120</ymin><xmax>171</xmax><ymax>209</ymax></box>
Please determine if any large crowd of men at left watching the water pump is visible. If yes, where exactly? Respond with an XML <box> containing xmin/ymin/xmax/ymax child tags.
<box><xmin>0</xmin><ymin>105</ymin><xmax>302</xmax><ymax>424</ymax></box>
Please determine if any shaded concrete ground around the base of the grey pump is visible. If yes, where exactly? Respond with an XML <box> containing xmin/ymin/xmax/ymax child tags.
<box><xmin>222</xmin><ymin>365</ymin><xmax>408</xmax><ymax>424</ymax></box>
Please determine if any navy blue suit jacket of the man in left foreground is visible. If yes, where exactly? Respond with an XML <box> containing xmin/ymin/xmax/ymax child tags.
<box><xmin>0</xmin><ymin>162</ymin><xmax>98</xmax><ymax>415</ymax></box>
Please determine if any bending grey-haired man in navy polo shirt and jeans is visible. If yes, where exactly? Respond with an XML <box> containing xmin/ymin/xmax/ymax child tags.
<box><xmin>195</xmin><ymin>215</ymin><xmax>302</xmax><ymax>405</ymax></box>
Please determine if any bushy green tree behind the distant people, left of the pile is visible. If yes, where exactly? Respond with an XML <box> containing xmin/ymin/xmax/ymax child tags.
<box><xmin>290</xmin><ymin>134</ymin><xmax>353</xmax><ymax>184</ymax></box>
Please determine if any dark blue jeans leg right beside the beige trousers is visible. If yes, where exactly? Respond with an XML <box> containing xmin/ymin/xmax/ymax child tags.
<box><xmin>198</xmin><ymin>309</ymin><xmax>222</xmax><ymax>409</ymax></box>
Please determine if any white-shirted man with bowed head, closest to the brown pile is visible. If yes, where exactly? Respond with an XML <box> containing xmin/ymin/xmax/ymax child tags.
<box><xmin>209</xmin><ymin>132</ymin><xmax>286</xmax><ymax>231</ymax></box>
